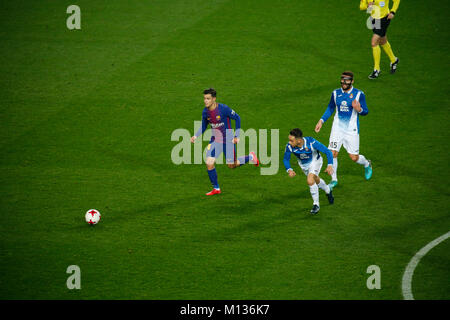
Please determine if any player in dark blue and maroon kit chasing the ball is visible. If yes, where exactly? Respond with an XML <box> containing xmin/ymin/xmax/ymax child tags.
<box><xmin>191</xmin><ymin>88</ymin><xmax>259</xmax><ymax>196</ymax></box>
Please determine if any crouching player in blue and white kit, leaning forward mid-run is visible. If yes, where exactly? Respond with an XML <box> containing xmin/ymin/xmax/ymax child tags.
<box><xmin>283</xmin><ymin>128</ymin><xmax>334</xmax><ymax>214</ymax></box>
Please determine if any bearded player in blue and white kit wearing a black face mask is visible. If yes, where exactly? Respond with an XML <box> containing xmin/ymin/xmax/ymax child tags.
<box><xmin>315</xmin><ymin>71</ymin><xmax>372</xmax><ymax>189</ymax></box>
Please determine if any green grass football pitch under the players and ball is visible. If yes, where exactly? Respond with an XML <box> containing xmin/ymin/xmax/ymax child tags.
<box><xmin>0</xmin><ymin>0</ymin><xmax>450</xmax><ymax>300</ymax></box>
